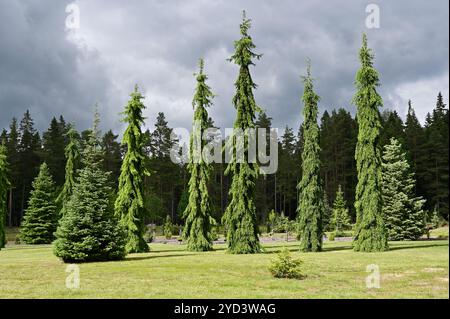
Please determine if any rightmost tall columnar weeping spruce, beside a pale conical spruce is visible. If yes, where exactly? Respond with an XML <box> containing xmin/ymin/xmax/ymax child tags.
<box><xmin>353</xmin><ymin>34</ymin><xmax>388</xmax><ymax>252</ymax></box>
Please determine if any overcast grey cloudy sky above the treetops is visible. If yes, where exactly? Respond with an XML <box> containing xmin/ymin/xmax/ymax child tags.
<box><xmin>0</xmin><ymin>0</ymin><xmax>449</xmax><ymax>133</ymax></box>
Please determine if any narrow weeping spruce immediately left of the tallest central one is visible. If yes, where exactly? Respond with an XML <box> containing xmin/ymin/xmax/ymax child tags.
<box><xmin>183</xmin><ymin>59</ymin><xmax>215</xmax><ymax>251</ymax></box>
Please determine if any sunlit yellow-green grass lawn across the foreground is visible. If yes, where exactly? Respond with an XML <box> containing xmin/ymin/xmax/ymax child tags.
<box><xmin>0</xmin><ymin>240</ymin><xmax>449</xmax><ymax>298</ymax></box>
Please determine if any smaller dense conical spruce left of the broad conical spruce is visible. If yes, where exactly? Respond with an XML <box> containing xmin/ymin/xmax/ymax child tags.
<box><xmin>20</xmin><ymin>162</ymin><xmax>58</xmax><ymax>244</ymax></box>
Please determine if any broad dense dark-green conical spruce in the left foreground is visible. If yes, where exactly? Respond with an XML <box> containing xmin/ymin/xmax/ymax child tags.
<box><xmin>54</xmin><ymin>113</ymin><xmax>126</xmax><ymax>262</ymax></box>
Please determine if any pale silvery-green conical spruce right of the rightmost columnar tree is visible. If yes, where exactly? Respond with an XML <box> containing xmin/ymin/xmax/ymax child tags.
<box><xmin>383</xmin><ymin>138</ymin><xmax>425</xmax><ymax>240</ymax></box>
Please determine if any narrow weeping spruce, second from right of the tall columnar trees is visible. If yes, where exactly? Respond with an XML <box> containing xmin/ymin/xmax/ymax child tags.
<box><xmin>297</xmin><ymin>61</ymin><xmax>324</xmax><ymax>252</ymax></box>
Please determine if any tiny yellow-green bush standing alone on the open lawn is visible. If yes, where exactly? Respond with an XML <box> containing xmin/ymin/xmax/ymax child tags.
<box><xmin>269</xmin><ymin>248</ymin><xmax>305</xmax><ymax>279</ymax></box>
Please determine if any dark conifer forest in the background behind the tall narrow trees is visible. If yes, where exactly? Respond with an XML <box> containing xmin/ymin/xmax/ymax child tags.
<box><xmin>0</xmin><ymin>93</ymin><xmax>448</xmax><ymax>230</ymax></box>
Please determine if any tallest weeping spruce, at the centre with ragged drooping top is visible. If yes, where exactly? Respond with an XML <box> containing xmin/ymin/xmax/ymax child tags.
<box><xmin>222</xmin><ymin>11</ymin><xmax>261</xmax><ymax>254</ymax></box>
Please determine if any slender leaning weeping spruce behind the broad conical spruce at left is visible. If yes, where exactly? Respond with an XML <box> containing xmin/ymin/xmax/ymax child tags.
<box><xmin>56</xmin><ymin>126</ymin><xmax>80</xmax><ymax>216</ymax></box>
